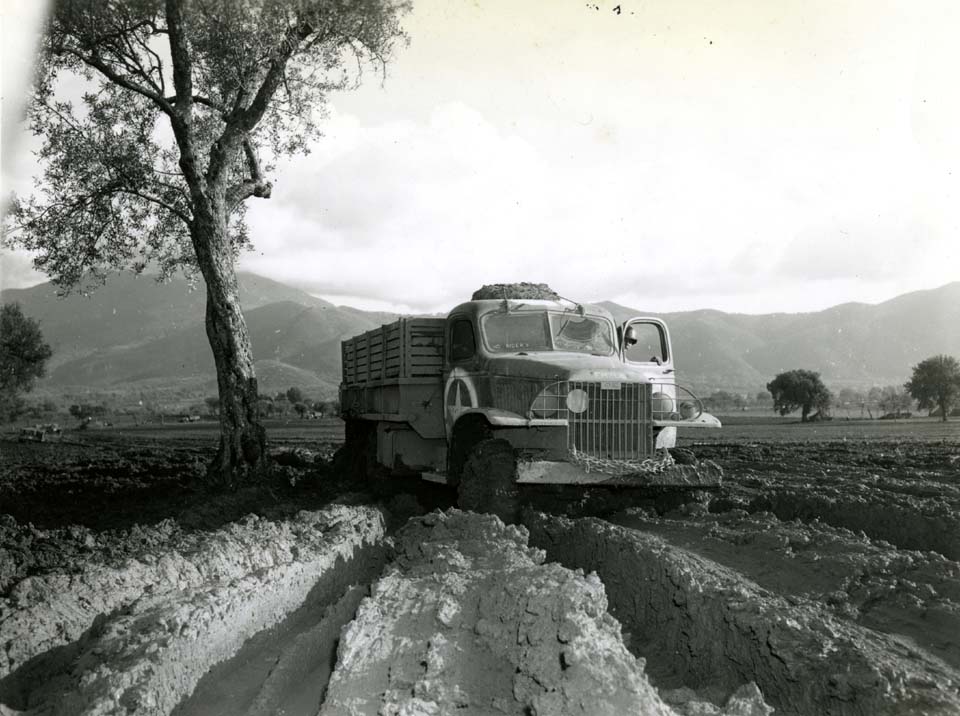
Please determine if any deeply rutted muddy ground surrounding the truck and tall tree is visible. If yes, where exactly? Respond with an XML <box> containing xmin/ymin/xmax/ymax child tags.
<box><xmin>0</xmin><ymin>433</ymin><xmax>960</xmax><ymax>716</ymax></box>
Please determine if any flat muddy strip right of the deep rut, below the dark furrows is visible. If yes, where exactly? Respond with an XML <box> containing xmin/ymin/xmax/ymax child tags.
<box><xmin>610</xmin><ymin>510</ymin><xmax>960</xmax><ymax>668</ymax></box>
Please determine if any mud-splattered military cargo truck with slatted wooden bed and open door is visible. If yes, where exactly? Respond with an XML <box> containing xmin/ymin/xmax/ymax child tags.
<box><xmin>340</xmin><ymin>286</ymin><xmax>721</xmax><ymax>519</ymax></box>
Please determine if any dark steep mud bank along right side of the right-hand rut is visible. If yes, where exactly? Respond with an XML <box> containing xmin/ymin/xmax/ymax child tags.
<box><xmin>526</xmin><ymin>514</ymin><xmax>960</xmax><ymax>716</ymax></box>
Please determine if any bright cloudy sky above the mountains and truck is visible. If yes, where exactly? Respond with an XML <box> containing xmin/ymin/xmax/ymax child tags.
<box><xmin>0</xmin><ymin>0</ymin><xmax>960</xmax><ymax>313</ymax></box>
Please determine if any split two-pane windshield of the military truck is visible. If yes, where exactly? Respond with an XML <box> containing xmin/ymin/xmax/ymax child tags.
<box><xmin>482</xmin><ymin>311</ymin><xmax>615</xmax><ymax>356</ymax></box>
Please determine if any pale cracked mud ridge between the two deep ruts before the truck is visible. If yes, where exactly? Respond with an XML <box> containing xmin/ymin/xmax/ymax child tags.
<box><xmin>321</xmin><ymin>510</ymin><xmax>674</xmax><ymax>716</ymax></box>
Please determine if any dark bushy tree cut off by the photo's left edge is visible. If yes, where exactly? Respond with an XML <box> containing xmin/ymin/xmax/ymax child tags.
<box><xmin>0</xmin><ymin>303</ymin><xmax>53</xmax><ymax>420</ymax></box>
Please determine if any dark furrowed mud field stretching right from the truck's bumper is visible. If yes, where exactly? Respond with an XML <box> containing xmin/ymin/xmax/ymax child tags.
<box><xmin>695</xmin><ymin>440</ymin><xmax>960</xmax><ymax>560</ymax></box>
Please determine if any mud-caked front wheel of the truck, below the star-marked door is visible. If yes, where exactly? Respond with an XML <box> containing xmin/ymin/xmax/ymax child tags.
<box><xmin>457</xmin><ymin>439</ymin><xmax>520</xmax><ymax>524</ymax></box>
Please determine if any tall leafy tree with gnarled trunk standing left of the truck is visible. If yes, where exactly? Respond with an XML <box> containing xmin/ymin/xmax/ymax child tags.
<box><xmin>5</xmin><ymin>0</ymin><xmax>409</xmax><ymax>486</ymax></box>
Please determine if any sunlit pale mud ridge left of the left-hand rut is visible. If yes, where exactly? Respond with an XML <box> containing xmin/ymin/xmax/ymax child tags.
<box><xmin>0</xmin><ymin>506</ymin><xmax>384</xmax><ymax>714</ymax></box>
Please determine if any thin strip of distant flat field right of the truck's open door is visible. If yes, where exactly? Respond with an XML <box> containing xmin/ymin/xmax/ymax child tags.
<box><xmin>679</xmin><ymin>415</ymin><xmax>960</xmax><ymax>444</ymax></box>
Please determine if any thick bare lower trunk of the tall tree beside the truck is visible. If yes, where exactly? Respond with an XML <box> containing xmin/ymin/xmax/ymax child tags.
<box><xmin>191</xmin><ymin>199</ymin><xmax>266</xmax><ymax>489</ymax></box>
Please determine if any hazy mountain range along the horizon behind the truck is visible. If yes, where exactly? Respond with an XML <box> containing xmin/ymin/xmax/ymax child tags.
<box><xmin>0</xmin><ymin>273</ymin><xmax>960</xmax><ymax>397</ymax></box>
